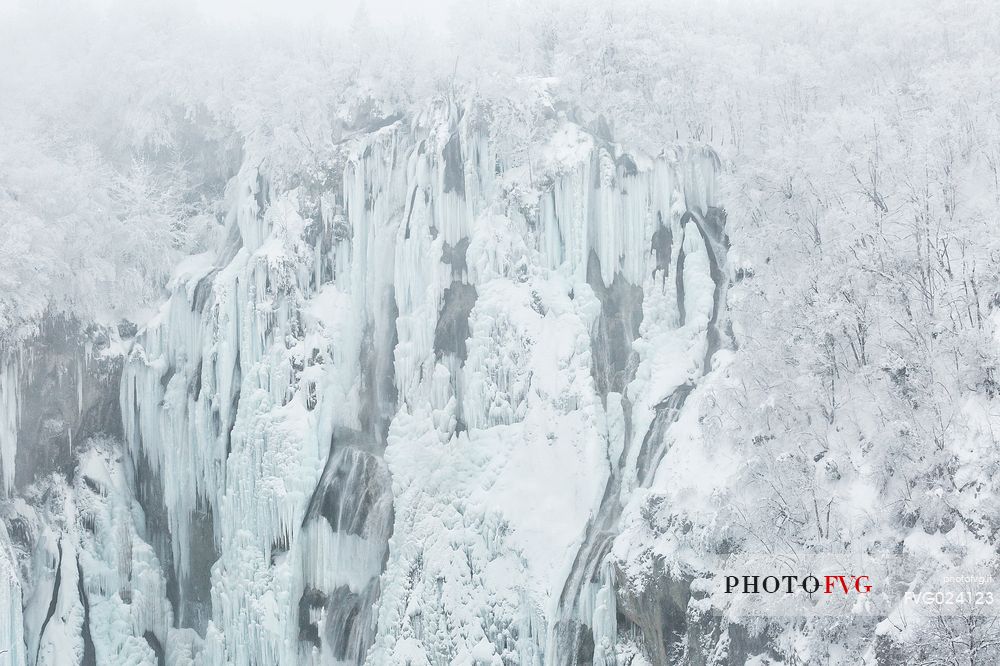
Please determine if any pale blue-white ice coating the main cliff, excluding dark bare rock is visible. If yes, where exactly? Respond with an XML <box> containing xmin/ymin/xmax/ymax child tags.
<box><xmin>109</xmin><ymin>100</ymin><xmax>714</xmax><ymax>663</ymax></box>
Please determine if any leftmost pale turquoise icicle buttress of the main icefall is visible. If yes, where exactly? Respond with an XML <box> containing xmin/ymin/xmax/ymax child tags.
<box><xmin>122</xmin><ymin>160</ymin><xmax>329</xmax><ymax>663</ymax></box>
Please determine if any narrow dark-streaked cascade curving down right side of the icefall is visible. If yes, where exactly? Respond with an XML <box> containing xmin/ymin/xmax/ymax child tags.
<box><xmin>547</xmin><ymin>169</ymin><xmax>731</xmax><ymax>664</ymax></box>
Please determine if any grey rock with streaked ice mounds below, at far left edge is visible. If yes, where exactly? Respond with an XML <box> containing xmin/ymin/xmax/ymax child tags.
<box><xmin>0</xmin><ymin>322</ymin><xmax>171</xmax><ymax>665</ymax></box>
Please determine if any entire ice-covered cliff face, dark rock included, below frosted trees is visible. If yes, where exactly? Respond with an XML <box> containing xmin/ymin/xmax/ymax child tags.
<box><xmin>0</xmin><ymin>103</ymin><xmax>731</xmax><ymax>664</ymax></box>
